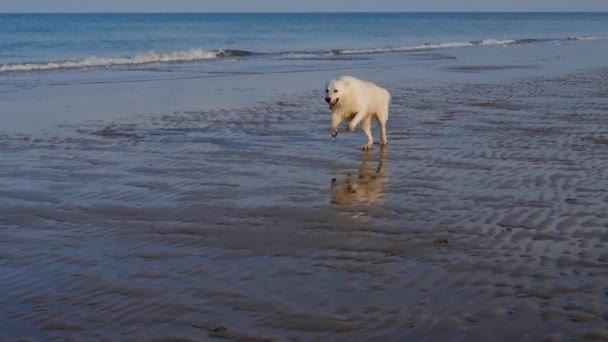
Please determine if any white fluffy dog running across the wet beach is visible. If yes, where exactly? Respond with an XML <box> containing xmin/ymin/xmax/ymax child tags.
<box><xmin>325</xmin><ymin>76</ymin><xmax>391</xmax><ymax>150</ymax></box>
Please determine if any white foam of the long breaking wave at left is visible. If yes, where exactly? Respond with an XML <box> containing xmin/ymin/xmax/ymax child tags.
<box><xmin>0</xmin><ymin>49</ymin><xmax>221</xmax><ymax>72</ymax></box>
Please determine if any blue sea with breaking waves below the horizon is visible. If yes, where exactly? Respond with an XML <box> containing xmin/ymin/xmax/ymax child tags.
<box><xmin>0</xmin><ymin>13</ymin><xmax>608</xmax><ymax>73</ymax></box>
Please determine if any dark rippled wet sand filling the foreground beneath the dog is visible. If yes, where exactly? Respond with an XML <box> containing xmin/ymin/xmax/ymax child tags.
<box><xmin>0</xmin><ymin>56</ymin><xmax>608</xmax><ymax>341</ymax></box>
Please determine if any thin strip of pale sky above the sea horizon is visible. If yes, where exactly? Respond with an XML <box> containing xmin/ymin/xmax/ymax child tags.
<box><xmin>0</xmin><ymin>0</ymin><xmax>608</xmax><ymax>12</ymax></box>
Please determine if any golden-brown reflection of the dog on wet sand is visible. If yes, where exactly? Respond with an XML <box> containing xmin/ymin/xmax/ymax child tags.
<box><xmin>331</xmin><ymin>149</ymin><xmax>388</xmax><ymax>205</ymax></box>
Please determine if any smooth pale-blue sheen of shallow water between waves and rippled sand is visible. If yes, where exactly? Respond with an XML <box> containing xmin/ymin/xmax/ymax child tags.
<box><xmin>0</xmin><ymin>41</ymin><xmax>608</xmax><ymax>134</ymax></box>
